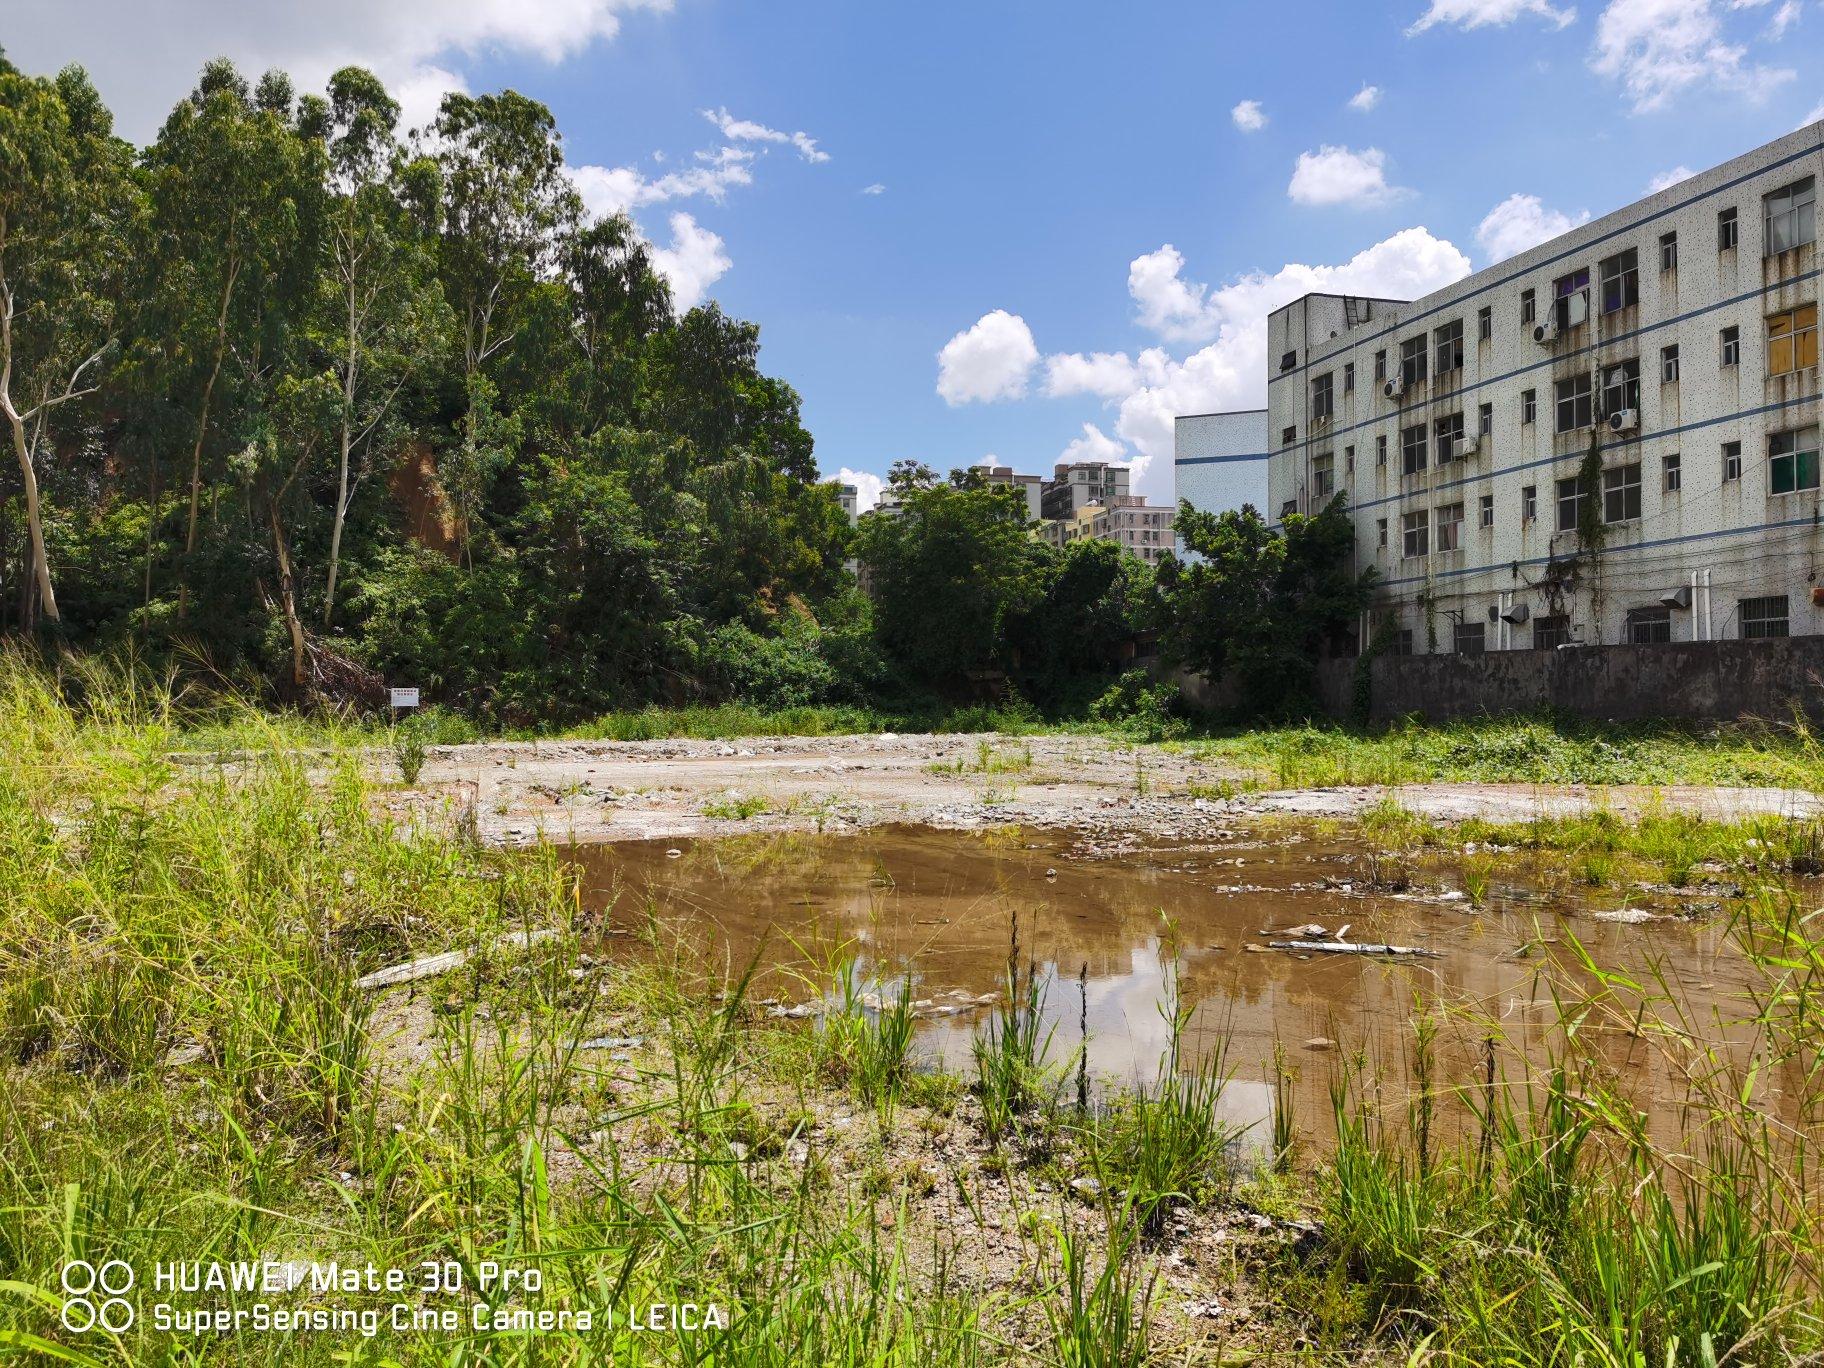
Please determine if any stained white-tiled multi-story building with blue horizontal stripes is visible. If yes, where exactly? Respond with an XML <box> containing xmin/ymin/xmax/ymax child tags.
<box><xmin>1268</xmin><ymin>124</ymin><xmax>1824</xmax><ymax>651</ymax></box>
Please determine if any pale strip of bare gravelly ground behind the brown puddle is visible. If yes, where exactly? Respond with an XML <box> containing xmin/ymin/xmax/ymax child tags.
<box><xmin>376</xmin><ymin>733</ymin><xmax>1824</xmax><ymax>846</ymax></box>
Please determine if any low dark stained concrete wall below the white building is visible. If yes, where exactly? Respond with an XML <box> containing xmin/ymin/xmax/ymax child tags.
<box><xmin>1372</xmin><ymin>637</ymin><xmax>1824</xmax><ymax>722</ymax></box>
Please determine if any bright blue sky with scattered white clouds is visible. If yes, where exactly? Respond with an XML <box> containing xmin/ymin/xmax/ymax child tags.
<box><xmin>14</xmin><ymin>0</ymin><xmax>1824</xmax><ymax>494</ymax></box>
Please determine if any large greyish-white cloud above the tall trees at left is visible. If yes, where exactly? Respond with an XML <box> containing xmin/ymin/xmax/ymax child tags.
<box><xmin>5</xmin><ymin>0</ymin><xmax>671</xmax><ymax>142</ymax></box>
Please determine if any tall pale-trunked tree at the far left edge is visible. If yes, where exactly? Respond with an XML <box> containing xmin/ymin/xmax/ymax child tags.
<box><xmin>0</xmin><ymin>57</ymin><xmax>131</xmax><ymax>622</ymax></box>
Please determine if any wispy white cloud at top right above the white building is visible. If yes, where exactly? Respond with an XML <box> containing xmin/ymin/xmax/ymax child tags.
<box><xmin>1591</xmin><ymin>0</ymin><xmax>1793</xmax><ymax>113</ymax></box>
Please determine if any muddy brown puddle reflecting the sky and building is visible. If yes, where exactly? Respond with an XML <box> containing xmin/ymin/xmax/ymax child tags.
<box><xmin>571</xmin><ymin>828</ymin><xmax>1747</xmax><ymax>1136</ymax></box>
